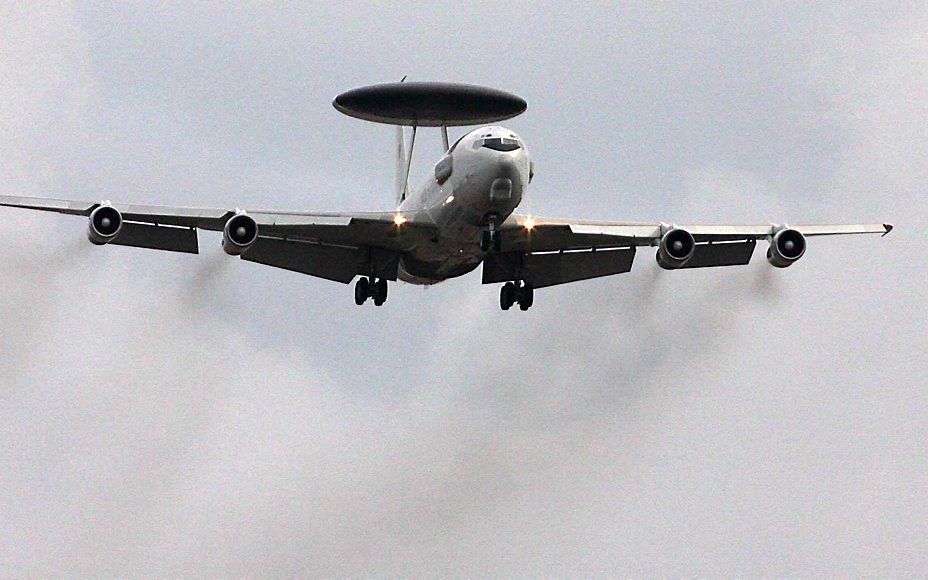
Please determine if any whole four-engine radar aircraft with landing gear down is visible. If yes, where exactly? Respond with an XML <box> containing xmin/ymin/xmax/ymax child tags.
<box><xmin>0</xmin><ymin>82</ymin><xmax>892</xmax><ymax>310</ymax></box>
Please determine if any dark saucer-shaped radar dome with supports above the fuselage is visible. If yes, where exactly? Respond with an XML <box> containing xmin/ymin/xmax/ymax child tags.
<box><xmin>332</xmin><ymin>76</ymin><xmax>527</xmax><ymax>201</ymax></box>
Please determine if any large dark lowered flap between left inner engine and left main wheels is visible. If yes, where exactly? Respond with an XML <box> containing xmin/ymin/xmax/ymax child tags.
<box><xmin>242</xmin><ymin>237</ymin><xmax>368</xmax><ymax>284</ymax></box>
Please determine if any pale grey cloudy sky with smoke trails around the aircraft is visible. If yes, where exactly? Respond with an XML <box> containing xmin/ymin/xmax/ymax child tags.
<box><xmin>0</xmin><ymin>2</ymin><xmax>928</xmax><ymax>576</ymax></box>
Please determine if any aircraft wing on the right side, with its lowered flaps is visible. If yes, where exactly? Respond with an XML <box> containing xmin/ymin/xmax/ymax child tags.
<box><xmin>483</xmin><ymin>214</ymin><xmax>892</xmax><ymax>288</ymax></box>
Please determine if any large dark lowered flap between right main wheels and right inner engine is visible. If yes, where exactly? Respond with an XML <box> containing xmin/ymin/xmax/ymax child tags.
<box><xmin>483</xmin><ymin>248</ymin><xmax>635</xmax><ymax>288</ymax></box>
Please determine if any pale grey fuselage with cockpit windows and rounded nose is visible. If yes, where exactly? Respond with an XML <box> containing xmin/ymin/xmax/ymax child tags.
<box><xmin>397</xmin><ymin>126</ymin><xmax>532</xmax><ymax>284</ymax></box>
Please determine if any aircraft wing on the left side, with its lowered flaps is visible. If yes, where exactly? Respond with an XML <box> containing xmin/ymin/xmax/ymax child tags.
<box><xmin>0</xmin><ymin>196</ymin><xmax>435</xmax><ymax>283</ymax></box>
